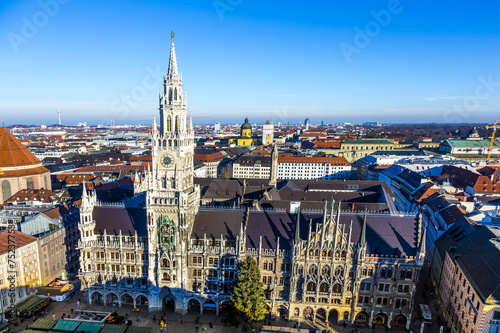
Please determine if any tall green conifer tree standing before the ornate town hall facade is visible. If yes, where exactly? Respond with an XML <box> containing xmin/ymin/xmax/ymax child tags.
<box><xmin>228</xmin><ymin>256</ymin><xmax>266</xmax><ymax>329</ymax></box>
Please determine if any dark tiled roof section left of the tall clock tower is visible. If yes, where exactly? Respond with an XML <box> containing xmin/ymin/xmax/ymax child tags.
<box><xmin>93</xmin><ymin>207</ymin><xmax>148</xmax><ymax>237</ymax></box>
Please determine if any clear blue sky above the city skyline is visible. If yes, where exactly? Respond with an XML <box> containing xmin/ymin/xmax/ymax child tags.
<box><xmin>0</xmin><ymin>0</ymin><xmax>500</xmax><ymax>125</ymax></box>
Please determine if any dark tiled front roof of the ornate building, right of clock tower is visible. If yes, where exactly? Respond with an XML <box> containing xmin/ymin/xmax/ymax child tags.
<box><xmin>192</xmin><ymin>209</ymin><xmax>417</xmax><ymax>256</ymax></box>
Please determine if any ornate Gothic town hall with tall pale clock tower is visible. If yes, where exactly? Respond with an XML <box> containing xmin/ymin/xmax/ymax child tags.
<box><xmin>78</xmin><ymin>33</ymin><xmax>425</xmax><ymax>329</ymax></box>
